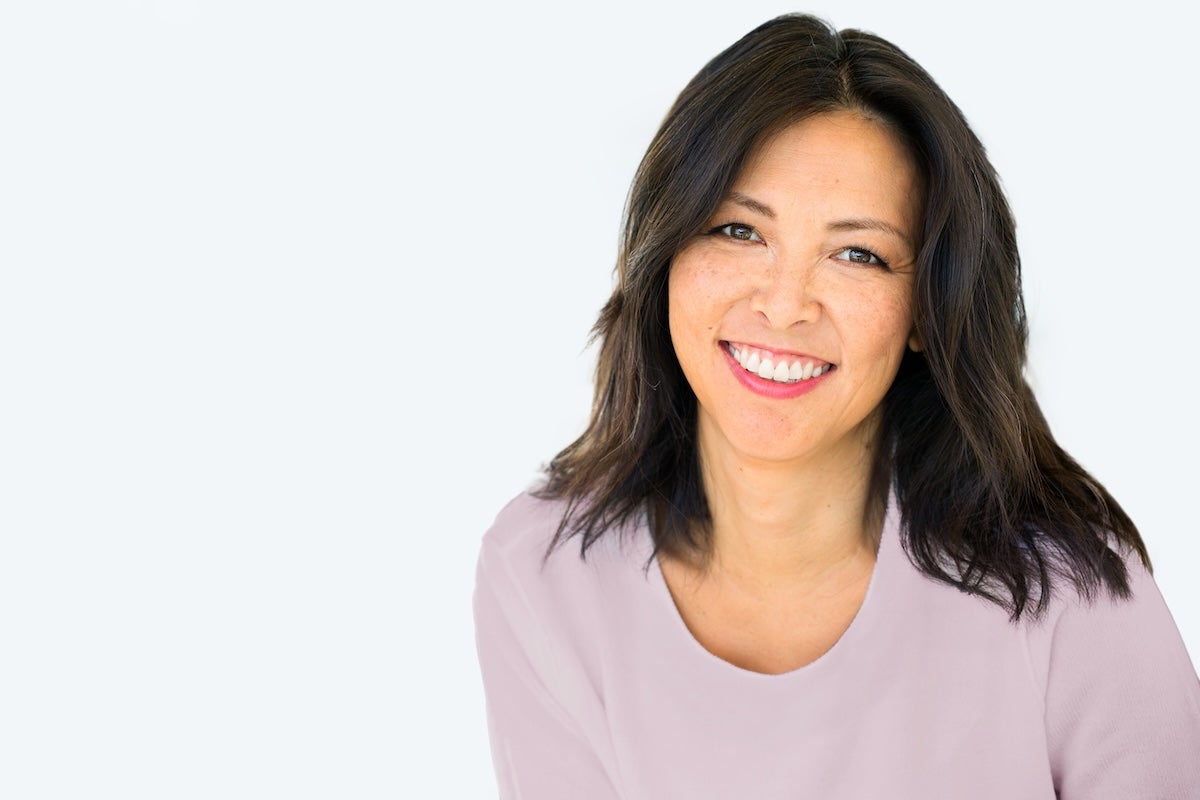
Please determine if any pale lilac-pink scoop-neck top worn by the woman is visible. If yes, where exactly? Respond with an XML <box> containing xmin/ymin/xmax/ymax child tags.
<box><xmin>474</xmin><ymin>494</ymin><xmax>1200</xmax><ymax>800</ymax></box>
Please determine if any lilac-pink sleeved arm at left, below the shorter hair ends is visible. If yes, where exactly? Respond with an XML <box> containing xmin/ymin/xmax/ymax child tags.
<box><xmin>474</xmin><ymin>540</ymin><xmax>620</xmax><ymax>800</ymax></box>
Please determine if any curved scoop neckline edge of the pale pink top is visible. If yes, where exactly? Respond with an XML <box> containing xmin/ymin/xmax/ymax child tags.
<box><xmin>642</xmin><ymin>493</ymin><xmax>900</xmax><ymax>684</ymax></box>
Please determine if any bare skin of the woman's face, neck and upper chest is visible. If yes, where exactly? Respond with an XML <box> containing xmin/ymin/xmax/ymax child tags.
<box><xmin>660</xmin><ymin>112</ymin><xmax>920</xmax><ymax>674</ymax></box>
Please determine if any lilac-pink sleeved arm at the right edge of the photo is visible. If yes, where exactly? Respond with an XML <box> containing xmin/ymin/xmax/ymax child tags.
<box><xmin>1045</xmin><ymin>557</ymin><xmax>1200</xmax><ymax>800</ymax></box>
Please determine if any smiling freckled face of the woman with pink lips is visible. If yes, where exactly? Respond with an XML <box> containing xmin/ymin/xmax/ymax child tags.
<box><xmin>668</xmin><ymin>112</ymin><xmax>922</xmax><ymax>470</ymax></box>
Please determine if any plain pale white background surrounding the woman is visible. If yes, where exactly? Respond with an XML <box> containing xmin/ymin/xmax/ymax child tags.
<box><xmin>0</xmin><ymin>0</ymin><xmax>1200</xmax><ymax>799</ymax></box>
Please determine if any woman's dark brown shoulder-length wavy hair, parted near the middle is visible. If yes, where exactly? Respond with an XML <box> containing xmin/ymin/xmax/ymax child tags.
<box><xmin>538</xmin><ymin>14</ymin><xmax>1150</xmax><ymax>621</ymax></box>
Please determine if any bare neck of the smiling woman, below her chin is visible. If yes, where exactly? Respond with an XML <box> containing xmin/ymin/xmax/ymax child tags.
<box><xmin>698</xmin><ymin>417</ymin><xmax>882</xmax><ymax>594</ymax></box>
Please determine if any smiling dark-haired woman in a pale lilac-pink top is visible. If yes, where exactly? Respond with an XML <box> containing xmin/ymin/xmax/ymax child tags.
<box><xmin>475</xmin><ymin>16</ymin><xmax>1200</xmax><ymax>800</ymax></box>
